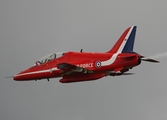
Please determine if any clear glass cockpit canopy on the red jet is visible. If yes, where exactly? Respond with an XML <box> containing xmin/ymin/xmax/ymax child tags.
<box><xmin>37</xmin><ymin>52</ymin><xmax>65</xmax><ymax>64</ymax></box>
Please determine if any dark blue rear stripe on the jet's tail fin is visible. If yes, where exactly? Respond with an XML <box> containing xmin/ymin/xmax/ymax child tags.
<box><xmin>122</xmin><ymin>26</ymin><xmax>137</xmax><ymax>53</ymax></box>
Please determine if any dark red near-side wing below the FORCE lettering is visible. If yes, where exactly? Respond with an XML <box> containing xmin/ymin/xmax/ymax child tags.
<box><xmin>57</xmin><ymin>63</ymin><xmax>93</xmax><ymax>75</ymax></box>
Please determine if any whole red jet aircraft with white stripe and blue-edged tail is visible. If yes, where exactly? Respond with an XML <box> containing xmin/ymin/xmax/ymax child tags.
<box><xmin>13</xmin><ymin>26</ymin><xmax>159</xmax><ymax>83</ymax></box>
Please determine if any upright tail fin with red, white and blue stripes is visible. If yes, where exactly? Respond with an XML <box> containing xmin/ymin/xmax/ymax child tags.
<box><xmin>108</xmin><ymin>26</ymin><xmax>137</xmax><ymax>53</ymax></box>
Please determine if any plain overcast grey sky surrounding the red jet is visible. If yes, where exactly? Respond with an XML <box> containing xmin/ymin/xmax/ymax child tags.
<box><xmin>0</xmin><ymin>0</ymin><xmax>167</xmax><ymax>120</ymax></box>
